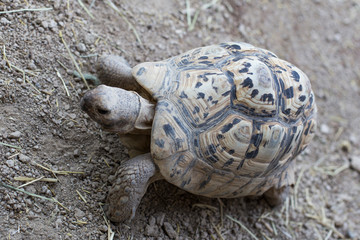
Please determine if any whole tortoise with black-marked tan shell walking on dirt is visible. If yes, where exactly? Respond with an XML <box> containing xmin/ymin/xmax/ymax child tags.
<box><xmin>81</xmin><ymin>42</ymin><xmax>316</xmax><ymax>222</ymax></box>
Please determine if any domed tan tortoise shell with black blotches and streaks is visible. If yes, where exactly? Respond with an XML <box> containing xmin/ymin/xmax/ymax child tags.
<box><xmin>133</xmin><ymin>43</ymin><xmax>316</xmax><ymax>198</ymax></box>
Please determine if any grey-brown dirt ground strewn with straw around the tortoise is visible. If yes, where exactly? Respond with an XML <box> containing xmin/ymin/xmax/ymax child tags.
<box><xmin>0</xmin><ymin>0</ymin><xmax>360</xmax><ymax>239</ymax></box>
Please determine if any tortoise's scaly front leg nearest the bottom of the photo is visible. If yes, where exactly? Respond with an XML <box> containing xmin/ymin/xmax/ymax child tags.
<box><xmin>104</xmin><ymin>153</ymin><xmax>162</xmax><ymax>222</ymax></box>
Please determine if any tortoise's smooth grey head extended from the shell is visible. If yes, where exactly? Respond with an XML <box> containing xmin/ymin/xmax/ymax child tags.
<box><xmin>80</xmin><ymin>85</ymin><xmax>140</xmax><ymax>134</ymax></box>
